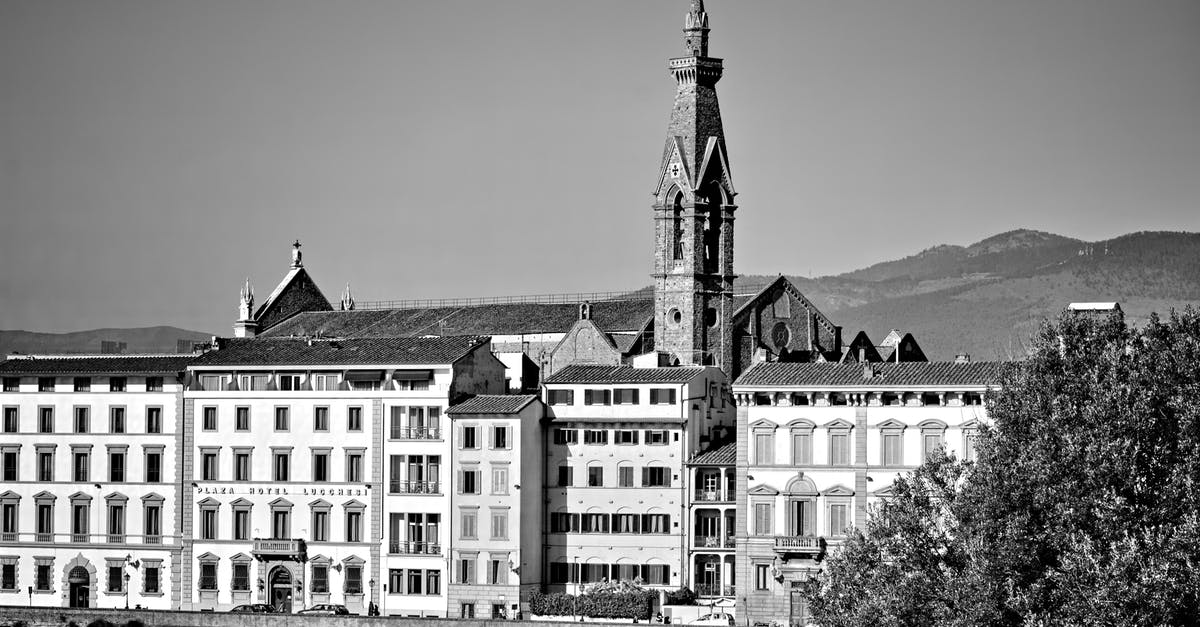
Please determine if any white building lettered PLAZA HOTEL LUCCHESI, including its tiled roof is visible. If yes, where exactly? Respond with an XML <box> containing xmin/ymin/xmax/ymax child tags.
<box><xmin>181</xmin><ymin>336</ymin><xmax>504</xmax><ymax>615</ymax></box>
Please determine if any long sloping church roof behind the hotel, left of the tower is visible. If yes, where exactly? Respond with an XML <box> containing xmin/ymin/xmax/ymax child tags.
<box><xmin>259</xmin><ymin>298</ymin><xmax>654</xmax><ymax>338</ymax></box>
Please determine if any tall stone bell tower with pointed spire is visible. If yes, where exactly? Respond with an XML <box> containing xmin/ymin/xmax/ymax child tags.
<box><xmin>653</xmin><ymin>0</ymin><xmax>737</xmax><ymax>372</ymax></box>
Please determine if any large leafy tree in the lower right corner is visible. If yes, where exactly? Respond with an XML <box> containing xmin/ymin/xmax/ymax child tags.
<box><xmin>808</xmin><ymin>309</ymin><xmax>1200</xmax><ymax>627</ymax></box>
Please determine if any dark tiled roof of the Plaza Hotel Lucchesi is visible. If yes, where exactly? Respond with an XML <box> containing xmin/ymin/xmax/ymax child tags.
<box><xmin>191</xmin><ymin>335</ymin><xmax>490</xmax><ymax>368</ymax></box>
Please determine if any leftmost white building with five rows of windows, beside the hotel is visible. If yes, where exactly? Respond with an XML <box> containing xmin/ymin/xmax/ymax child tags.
<box><xmin>0</xmin><ymin>356</ymin><xmax>191</xmax><ymax>609</ymax></box>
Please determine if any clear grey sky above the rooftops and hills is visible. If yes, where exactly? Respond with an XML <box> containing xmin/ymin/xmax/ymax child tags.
<box><xmin>0</xmin><ymin>0</ymin><xmax>1200</xmax><ymax>334</ymax></box>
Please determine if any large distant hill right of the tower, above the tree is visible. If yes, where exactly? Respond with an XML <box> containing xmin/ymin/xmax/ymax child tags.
<box><xmin>738</xmin><ymin>231</ymin><xmax>1200</xmax><ymax>359</ymax></box>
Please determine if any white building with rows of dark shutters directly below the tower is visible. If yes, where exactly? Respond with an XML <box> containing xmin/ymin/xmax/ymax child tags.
<box><xmin>544</xmin><ymin>365</ymin><xmax>736</xmax><ymax>592</ymax></box>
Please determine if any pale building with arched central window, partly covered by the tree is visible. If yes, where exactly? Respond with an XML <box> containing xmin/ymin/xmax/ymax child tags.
<box><xmin>733</xmin><ymin>360</ymin><xmax>1001</xmax><ymax>625</ymax></box>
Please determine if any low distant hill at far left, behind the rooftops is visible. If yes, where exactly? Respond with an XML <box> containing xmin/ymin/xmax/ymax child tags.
<box><xmin>0</xmin><ymin>327</ymin><xmax>212</xmax><ymax>358</ymax></box>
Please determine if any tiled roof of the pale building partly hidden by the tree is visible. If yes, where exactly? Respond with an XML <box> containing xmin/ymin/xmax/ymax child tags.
<box><xmin>733</xmin><ymin>362</ymin><xmax>1004</xmax><ymax>388</ymax></box>
